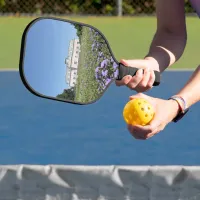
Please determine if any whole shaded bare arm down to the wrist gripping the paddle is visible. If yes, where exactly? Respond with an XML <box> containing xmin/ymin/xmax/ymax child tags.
<box><xmin>146</xmin><ymin>0</ymin><xmax>187</xmax><ymax>72</ymax></box>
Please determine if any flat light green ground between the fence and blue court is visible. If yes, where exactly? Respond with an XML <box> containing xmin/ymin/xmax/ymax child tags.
<box><xmin>0</xmin><ymin>17</ymin><xmax>200</xmax><ymax>68</ymax></box>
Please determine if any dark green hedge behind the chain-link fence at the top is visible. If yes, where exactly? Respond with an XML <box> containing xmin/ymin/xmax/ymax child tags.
<box><xmin>0</xmin><ymin>0</ymin><xmax>193</xmax><ymax>15</ymax></box>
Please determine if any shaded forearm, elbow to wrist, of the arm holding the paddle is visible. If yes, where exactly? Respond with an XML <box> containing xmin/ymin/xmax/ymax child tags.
<box><xmin>145</xmin><ymin>31</ymin><xmax>187</xmax><ymax>72</ymax></box>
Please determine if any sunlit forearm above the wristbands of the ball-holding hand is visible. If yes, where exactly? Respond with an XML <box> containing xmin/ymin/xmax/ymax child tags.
<box><xmin>177</xmin><ymin>66</ymin><xmax>200</xmax><ymax>107</ymax></box>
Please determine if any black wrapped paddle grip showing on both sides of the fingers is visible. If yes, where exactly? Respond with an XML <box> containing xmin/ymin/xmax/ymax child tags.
<box><xmin>117</xmin><ymin>63</ymin><xmax>160</xmax><ymax>86</ymax></box>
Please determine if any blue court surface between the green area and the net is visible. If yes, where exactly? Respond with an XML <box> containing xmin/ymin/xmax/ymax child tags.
<box><xmin>0</xmin><ymin>71</ymin><xmax>200</xmax><ymax>165</ymax></box>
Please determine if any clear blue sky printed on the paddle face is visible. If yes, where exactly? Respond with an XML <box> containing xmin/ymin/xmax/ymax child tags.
<box><xmin>24</xmin><ymin>19</ymin><xmax>78</xmax><ymax>97</ymax></box>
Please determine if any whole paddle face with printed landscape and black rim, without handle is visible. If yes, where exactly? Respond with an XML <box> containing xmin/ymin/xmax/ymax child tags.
<box><xmin>20</xmin><ymin>18</ymin><xmax>119</xmax><ymax>104</ymax></box>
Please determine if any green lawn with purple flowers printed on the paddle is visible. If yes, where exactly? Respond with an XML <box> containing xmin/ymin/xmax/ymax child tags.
<box><xmin>75</xmin><ymin>27</ymin><xmax>117</xmax><ymax>103</ymax></box>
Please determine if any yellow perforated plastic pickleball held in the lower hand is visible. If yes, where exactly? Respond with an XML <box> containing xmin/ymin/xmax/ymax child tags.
<box><xmin>123</xmin><ymin>98</ymin><xmax>155</xmax><ymax>126</ymax></box>
